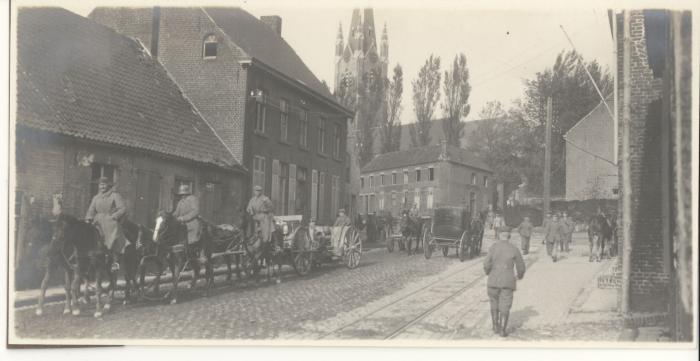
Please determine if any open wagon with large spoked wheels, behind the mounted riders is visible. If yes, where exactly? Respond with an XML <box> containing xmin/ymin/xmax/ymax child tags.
<box><xmin>275</xmin><ymin>215</ymin><xmax>362</xmax><ymax>276</ymax></box>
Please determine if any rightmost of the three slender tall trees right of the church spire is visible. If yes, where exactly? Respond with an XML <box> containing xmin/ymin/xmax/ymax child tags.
<box><xmin>442</xmin><ymin>54</ymin><xmax>471</xmax><ymax>147</ymax></box>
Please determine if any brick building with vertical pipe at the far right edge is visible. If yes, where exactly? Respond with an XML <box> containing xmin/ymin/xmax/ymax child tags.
<box><xmin>612</xmin><ymin>10</ymin><xmax>697</xmax><ymax>341</ymax></box>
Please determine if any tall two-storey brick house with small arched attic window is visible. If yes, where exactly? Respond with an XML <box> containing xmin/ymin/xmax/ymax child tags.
<box><xmin>89</xmin><ymin>7</ymin><xmax>353</xmax><ymax>224</ymax></box>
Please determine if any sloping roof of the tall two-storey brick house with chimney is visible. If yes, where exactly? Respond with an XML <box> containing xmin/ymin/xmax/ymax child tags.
<box><xmin>204</xmin><ymin>7</ymin><xmax>337</xmax><ymax>103</ymax></box>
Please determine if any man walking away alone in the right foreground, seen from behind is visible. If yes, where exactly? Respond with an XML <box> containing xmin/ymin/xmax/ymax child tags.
<box><xmin>484</xmin><ymin>231</ymin><xmax>525</xmax><ymax>337</ymax></box>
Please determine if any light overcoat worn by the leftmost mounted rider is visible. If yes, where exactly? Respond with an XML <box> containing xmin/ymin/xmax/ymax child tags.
<box><xmin>85</xmin><ymin>189</ymin><xmax>126</xmax><ymax>253</ymax></box>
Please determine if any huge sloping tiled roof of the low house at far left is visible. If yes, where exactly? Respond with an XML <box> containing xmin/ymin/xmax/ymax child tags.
<box><xmin>17</xmin><ymin>8</ymin><xmax>239</xmax><ymax>167</ymax></box>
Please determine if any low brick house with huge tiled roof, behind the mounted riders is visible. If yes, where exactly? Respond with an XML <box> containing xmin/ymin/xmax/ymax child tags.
<box><xmin>14</xmin><ymin>8</ymin><xmax>245</xmax><ymax>284</ymax></box>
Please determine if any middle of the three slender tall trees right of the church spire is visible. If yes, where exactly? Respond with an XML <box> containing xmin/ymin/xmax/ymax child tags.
<box><xmin>410</xmin><ymin>54</ymin><xmax>440</xmax><ymax>147</ymax></box>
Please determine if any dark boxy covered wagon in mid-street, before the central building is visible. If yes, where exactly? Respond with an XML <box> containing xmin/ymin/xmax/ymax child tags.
<box><xmin>423</xmin><ymin>207</ymin><xmax>476</xmax><ymax>261</ymax></box>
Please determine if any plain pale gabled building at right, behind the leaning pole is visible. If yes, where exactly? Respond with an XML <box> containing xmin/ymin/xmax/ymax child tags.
<box><xmin>564</xmin><ymin>97</ymin><xmax>619</xmax><ymax>200</ymax></box>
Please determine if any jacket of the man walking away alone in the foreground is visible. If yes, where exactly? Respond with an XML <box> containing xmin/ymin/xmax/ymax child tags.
<box><xmin>484</xmin><ymin>241</ymin><xmax>525</xmax><ymax>290</ymax></box>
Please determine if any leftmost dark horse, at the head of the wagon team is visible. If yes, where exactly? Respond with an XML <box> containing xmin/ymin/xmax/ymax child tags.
<box><xmin>36</xmin><ymin>212</ymin><xmax>109</xmax><ymax>317</ymax></box>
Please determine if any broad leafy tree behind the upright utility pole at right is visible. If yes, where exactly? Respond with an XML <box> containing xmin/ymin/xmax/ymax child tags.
<box><xmin>519</xmin><ymin>51</ymin><xmax>613</xmax><ymax>195</ymax></box>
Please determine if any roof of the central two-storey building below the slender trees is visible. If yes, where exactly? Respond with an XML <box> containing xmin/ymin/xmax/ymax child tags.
<box><xmin>362</xmin><ymin>145</ymin><xmax>491</xmax><ymax>173</ymax></box>
